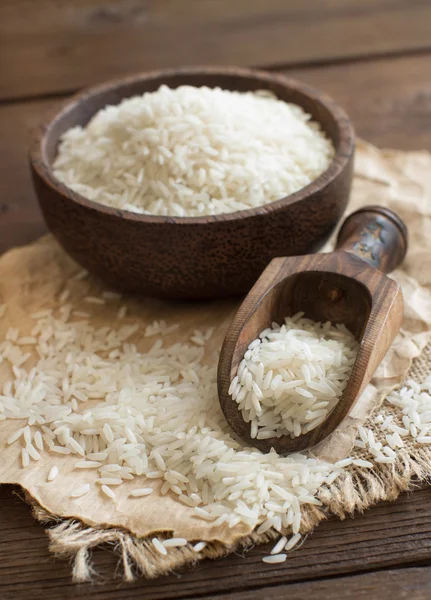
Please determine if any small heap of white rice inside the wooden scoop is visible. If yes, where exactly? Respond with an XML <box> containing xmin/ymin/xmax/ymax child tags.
<box><xmin>229</xmin><ymin>313</ymin><xmax>358</xmax><ymax>439</ymax></box>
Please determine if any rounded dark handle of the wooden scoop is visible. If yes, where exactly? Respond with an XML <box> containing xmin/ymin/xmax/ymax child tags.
<box><xmin>336</xmin><ymin>206</ymin><xmax>407</xmax><ymax>273</ymax></box>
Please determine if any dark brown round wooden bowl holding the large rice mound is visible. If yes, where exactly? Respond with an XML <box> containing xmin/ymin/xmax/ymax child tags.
<box><xmin>30</xmin><ymin>67</ymin><xmax>354</xmax><ymax>299</ymax></box>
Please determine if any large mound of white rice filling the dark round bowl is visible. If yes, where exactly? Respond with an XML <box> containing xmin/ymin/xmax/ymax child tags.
<box><xmin>54</xmin><ymin>85</ymin><xmax>334</xmax><ymax>217</ymax></box>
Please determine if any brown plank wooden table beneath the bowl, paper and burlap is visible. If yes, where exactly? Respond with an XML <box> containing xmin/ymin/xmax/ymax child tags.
<box><xmin>0</xmin><ymin>0</ymin><xmax>431</xmax><ymax>600</ymax></box>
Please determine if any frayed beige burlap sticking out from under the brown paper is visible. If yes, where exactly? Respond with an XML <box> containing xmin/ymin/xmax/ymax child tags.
<box><xmin>22</xmin><ymin>345</ymin><xmax>431</xmax><ymax>582</ymax></box>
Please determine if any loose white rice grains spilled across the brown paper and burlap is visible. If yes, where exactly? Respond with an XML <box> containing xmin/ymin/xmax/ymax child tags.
<box><xmin>0</xmin><ymin>273</ymin><xmax>431</xmax><ymax>563</ymax></box>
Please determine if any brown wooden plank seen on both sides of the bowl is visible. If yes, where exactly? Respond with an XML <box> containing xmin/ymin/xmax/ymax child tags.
<box><xmin>0</xmin><ymin>55</ymin><xmax>431</xmax><ymax>252</ymax></box>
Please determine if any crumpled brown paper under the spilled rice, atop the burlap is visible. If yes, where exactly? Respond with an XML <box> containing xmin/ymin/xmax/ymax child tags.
<box><xmin>0</xmin><ymin>142</ymin><xmax>431</xmax><ymax>545</ymax></box>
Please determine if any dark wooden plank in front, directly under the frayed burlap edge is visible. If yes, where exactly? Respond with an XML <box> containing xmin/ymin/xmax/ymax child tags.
<box><xmin>0</xmin><ymin>486</ymin><xmax>431</xmax><ymax>600</ymax></box>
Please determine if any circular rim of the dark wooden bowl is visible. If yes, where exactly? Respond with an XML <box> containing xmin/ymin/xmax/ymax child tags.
<box><xmin>29</xmin><ymin>66</ymin><xmax>355</xmax><ymax>225</ymax></box>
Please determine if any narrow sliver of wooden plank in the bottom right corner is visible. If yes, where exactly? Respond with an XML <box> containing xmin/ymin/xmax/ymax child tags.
<box><xmin>207</xmin><ymin>567</ymin><xmax>431</xmax><ymax>600</ymax></box>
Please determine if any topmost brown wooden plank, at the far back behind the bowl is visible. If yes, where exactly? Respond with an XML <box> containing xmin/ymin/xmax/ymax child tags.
<box><xmin>0</xmin><ymin>0</ymin><xmax>431</xmax><ymax>99</ymax></box>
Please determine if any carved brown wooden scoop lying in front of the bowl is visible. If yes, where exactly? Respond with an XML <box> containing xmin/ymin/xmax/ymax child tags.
<box><xmin>217</xmin><ymin>206</ymin><xmax>407</xmax><ymax>454</ymax></box>
